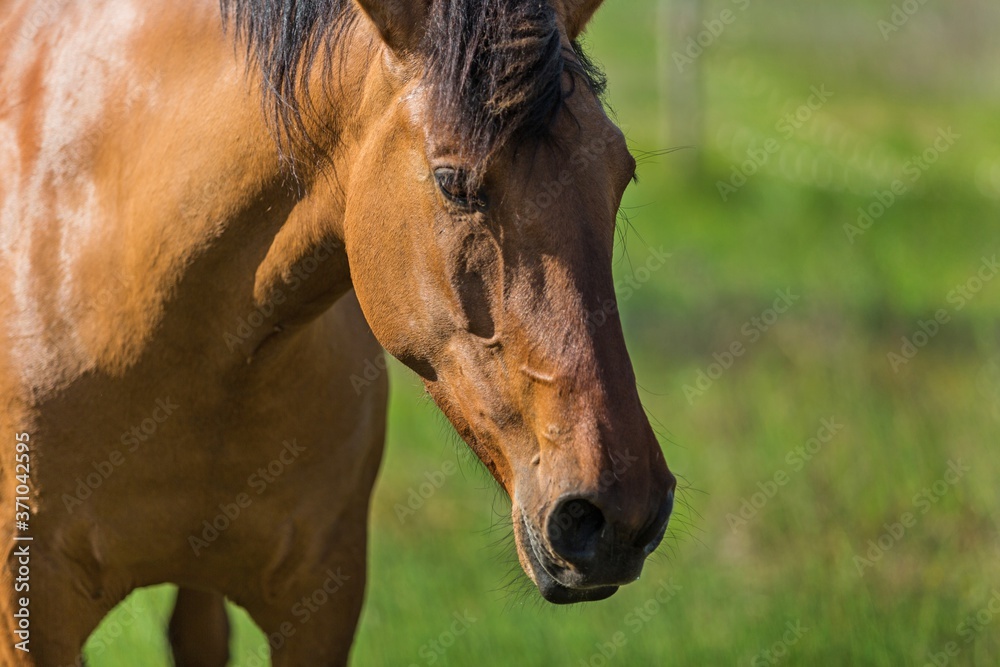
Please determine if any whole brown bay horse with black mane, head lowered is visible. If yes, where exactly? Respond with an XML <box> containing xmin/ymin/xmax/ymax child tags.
<box><xmin>0</xmin><ymin>0</ymin><xmax>676</xmax><ymax>667</ymax></box>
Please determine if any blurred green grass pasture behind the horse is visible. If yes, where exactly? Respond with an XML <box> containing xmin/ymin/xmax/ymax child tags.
<box><xmin>88</xmin><ymin>0</ymin><xmax>1000</xmax><ymax>667</ymax></box>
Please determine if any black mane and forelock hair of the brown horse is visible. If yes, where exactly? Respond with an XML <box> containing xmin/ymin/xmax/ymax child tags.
<box><xmin>220</xmin><ymin>0</ymin><xmax>604</xmax><ymax>175</ymax></box>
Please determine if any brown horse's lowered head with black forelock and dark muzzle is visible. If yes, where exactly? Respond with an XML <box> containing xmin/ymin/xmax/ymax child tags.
<box><xmin>343</xmin><ymin>0</ymin><xmax>676</xmax><ymax>603</ymax></box>
